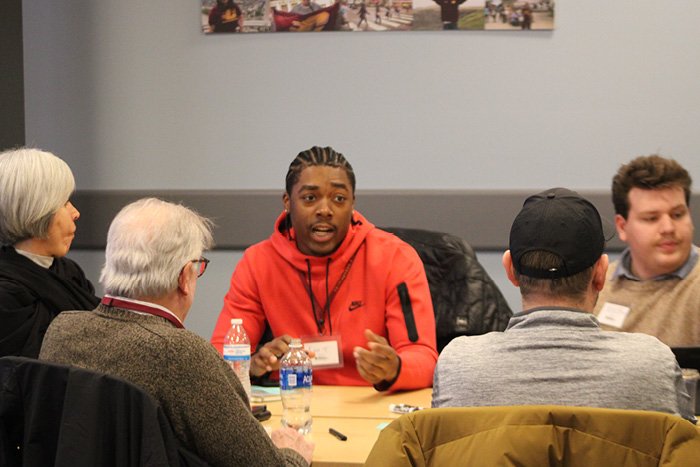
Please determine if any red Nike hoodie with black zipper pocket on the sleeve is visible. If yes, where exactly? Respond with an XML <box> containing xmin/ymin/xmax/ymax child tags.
<box><xmin>212</xmin><ymin>211</ymin><xmax>437</xmax><ymax>391</ymax></box>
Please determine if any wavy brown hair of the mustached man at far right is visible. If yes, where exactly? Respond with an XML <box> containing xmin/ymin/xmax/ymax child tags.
<box><xmin>612</xmin><ymin>154</ymin><xmax>693</xmax><ymax>219</ymax></box>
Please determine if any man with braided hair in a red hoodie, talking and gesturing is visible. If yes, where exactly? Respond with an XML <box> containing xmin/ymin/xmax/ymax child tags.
<box><xmin>212</xmin><ymin>146</ymin><xmax>437</xmax><ymax>391</ymax></box>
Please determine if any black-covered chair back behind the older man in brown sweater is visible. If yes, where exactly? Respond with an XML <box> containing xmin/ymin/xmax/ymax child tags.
<box><xmin>0</xmin><ymin>357</ymin><xmax>207</xmax><ymax>467</ymax></box>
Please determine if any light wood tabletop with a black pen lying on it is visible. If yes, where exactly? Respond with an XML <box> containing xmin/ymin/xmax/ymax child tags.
<box><xmin>263</xmin><ymin>386</ymin><xmax>432</xmax><ymax>467</ymax></box>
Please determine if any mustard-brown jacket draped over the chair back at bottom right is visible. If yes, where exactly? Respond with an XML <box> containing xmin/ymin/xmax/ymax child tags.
<box><xmin>365</xmin><ymin>406</ymin><xmax>700</xmax><ymax>467</ymax></box>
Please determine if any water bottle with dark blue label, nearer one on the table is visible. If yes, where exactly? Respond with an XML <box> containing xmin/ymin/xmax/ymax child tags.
<box><xmin>280</xmin><ymin>339</ymin><xmax>313</xmax><ymax>434</ymax></box>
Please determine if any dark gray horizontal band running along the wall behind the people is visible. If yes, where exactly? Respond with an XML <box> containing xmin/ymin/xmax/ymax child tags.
<box><xmin>73</xmin><ymin>190</ymin><xmax>700</xmax><ymax>251</ymax></box>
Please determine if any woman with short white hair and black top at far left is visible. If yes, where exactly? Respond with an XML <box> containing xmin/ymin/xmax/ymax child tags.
<box><xmin>0</xmin><ymin>149</ymin><xmax>99</xmax><ymax>357</ymax></box>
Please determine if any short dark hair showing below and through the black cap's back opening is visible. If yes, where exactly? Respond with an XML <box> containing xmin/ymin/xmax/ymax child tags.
<box><xmin>515</xmin><ymin>250</ymin><xmax>595</xmax><ymax>300</ymax></box>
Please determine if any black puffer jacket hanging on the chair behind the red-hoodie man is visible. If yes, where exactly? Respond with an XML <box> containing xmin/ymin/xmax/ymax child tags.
<box><xmin>382</xmin><ymin>227</ymin><xmax>513</xmax><ymax>352</ymax></box>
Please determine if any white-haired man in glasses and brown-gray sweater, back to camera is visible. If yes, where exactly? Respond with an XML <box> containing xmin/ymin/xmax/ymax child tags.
<box><xmin>39</xmin><ymin>198</ymin><xmax>313</xmax><ymax>466</ymax></box>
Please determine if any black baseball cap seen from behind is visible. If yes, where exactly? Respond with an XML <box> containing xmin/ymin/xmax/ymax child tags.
<box><xmin>510</xmin><ymin>188</ymin><xmax>606</xmax><ymax>279</ymax></box>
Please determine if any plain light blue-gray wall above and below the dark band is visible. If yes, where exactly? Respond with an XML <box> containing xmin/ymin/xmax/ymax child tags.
<box><xmin>23</xmin><ymin>0</ymin><xmax>700</xmax><ymax>337</ymax></box>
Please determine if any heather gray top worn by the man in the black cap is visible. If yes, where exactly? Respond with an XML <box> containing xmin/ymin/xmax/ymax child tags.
<box><xmin>432</xmin><ymin>308</ymin><xmax>694</xmax><ymax>420</ymax></box>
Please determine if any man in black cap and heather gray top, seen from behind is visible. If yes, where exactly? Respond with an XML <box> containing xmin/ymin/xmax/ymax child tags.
<box><xmin>432</xmin><ymin>188</ymin><xmax>694</xmax><ymax>420</ymax></box>
